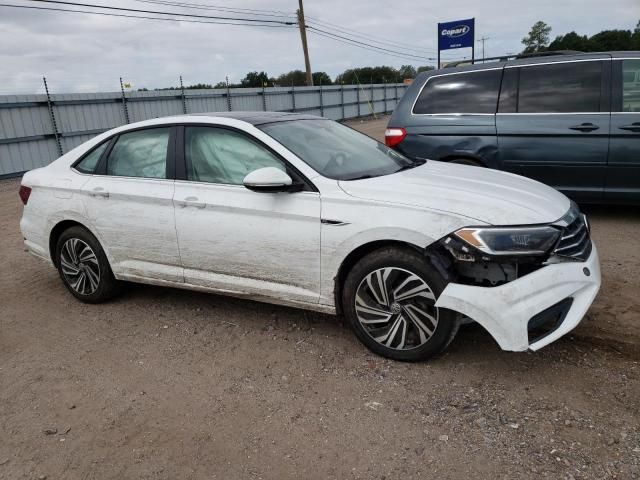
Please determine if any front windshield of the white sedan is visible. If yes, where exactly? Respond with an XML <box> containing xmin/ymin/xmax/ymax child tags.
<box><xmin>259</xmin><ymin>119</ymin><xmax>424</xmax><ymax>180</ymax></box>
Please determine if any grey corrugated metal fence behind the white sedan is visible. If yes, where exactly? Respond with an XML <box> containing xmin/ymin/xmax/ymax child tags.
<box><xmin>0</xmin><ymin>84</ymin><xmax>406</xmax><ymax>177</ymax></box>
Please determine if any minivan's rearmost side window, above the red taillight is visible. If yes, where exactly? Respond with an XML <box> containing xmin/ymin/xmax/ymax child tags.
<box><xmin>413</xmin><ymin>69</ymin><xmax>502</xmax><ymax>114</ymax></box>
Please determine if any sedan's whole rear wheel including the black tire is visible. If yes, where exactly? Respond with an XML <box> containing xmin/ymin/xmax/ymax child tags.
<box><xmin>55</xmin><ymin>226</ymin><xmax>119</xmax><ymax>303</ymax></box>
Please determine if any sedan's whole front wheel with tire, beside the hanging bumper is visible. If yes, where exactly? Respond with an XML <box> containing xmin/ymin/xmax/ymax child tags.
<box><xmin>342</xmin><ymin>247</ymin><xmax>459</xmax><ymax>362</ymax></box>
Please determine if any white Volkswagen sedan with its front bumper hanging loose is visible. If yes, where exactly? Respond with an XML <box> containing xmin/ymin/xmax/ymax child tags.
<box><xmin>20</xmin><ymin>112</ymin><xmax>600</xmax><ymax>361</ymax></box>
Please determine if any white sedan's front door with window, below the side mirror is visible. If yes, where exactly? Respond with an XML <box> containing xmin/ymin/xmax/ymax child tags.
<box><xmin>174</xmin><ymin>126</ymin><xmax>320</xmax><ymax>303</ymax></box>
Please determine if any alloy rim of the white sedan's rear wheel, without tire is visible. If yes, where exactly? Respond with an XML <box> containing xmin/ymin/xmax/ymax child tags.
<box><xmin>60</xmin><ymin>238</ymin><xmax>100</xmax><ymax>295</ymax></box>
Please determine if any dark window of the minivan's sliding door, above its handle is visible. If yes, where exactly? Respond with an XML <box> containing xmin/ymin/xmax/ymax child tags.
<box><xmin>507</xmin><ymin>61</ymin><xmax>602</xmax><ymax>113</ymax></box>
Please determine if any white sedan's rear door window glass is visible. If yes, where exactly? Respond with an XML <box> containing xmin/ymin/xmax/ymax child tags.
<box><xmin>107</xmin><ymin>128</ymin><xmax>170</xmax><ymax>178</ymax></box>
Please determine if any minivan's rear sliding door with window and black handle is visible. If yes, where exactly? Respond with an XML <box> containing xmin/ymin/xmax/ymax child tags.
<box><xmin>496</xmin><ymin>59</ymin><xmax>611</xmax><ymax>201</ymax></box>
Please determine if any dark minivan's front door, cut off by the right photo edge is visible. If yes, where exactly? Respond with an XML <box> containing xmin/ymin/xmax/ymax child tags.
<box><xmin>605</xmin><ymin>57</ymin><xmax>640</xmax><ymax>203</ymax></box>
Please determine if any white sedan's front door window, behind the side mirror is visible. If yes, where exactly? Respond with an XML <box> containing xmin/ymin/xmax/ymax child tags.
<box><xmin>184</xmin><ymin>127</ymin><xmax>286</xmax><ymax>185</ymax></box>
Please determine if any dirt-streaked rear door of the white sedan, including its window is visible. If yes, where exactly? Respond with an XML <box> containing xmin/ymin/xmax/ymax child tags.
<box><xmin>82</xmin><ymin>127</ymin><xmax>183</xmax><ymax>282</ymax></box>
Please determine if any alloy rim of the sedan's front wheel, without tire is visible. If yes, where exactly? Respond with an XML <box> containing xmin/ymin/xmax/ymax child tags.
<box><xmin>355</xmin><ymin>267</ymin><xmax>438</xmax><ymax>350</ymax></box>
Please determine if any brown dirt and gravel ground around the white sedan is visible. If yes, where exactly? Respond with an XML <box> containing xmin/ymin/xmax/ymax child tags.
<box><xmin>0</xmin><ymin>119</ymin><xmax>640</xmax><ymax>480</ymax></box>
